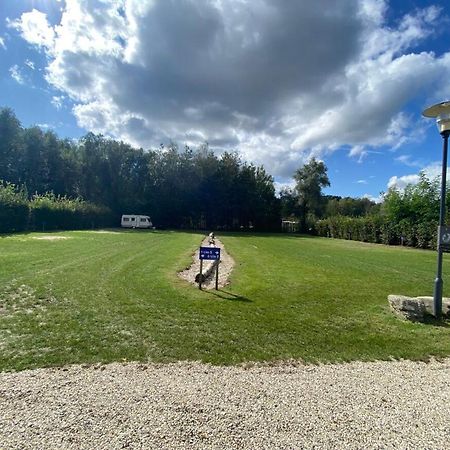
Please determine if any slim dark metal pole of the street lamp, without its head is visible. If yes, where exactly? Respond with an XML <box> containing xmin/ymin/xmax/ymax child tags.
<box><xmin>433</xmin><ymin>131</ymin><xmax>450</xmax><ymax>320</ymax></box>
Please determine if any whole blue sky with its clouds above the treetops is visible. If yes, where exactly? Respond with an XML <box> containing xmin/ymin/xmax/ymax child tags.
<box><xmin>0</xmin><ymin>0</ymin><xmax>450</xmax><ymax>199</ymax></box>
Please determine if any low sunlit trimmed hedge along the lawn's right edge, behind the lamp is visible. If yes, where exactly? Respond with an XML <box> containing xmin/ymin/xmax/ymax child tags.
<box><xmin>315</xmin><ymin>216</ymin><xmax>438</xmax><ymax>249</ymax></box>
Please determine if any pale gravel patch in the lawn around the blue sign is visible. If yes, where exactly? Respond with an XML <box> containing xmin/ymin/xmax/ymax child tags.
<box><xmin>178</xmin><ymin>237</ymin><xmax>234</xmax><ymax>289</ymax></box>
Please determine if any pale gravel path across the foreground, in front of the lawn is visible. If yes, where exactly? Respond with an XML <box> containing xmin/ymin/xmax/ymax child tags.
<box><xmin>0</xmin><ymin>359</ymin><xmax>450</xmax><ymax>450</ymax></box>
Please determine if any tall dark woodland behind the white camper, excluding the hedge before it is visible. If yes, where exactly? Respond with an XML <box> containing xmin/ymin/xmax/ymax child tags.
<box><xmin>0</xmin><ymin>108</ymin><xmax>280</xmax><ymax>230</ymax></box>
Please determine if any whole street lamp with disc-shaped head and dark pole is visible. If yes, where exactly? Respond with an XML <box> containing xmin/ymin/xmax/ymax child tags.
<box><xmin>422</xmin><ymin>101</ymin><xmax>450</xmax><ymax>319</ymax></box>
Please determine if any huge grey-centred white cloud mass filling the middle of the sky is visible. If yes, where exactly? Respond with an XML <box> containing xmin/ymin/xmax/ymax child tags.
<box><xmin>11</xmin><ymin>0</ymin><xmax>450</xmax><ymax>177</ymax></box>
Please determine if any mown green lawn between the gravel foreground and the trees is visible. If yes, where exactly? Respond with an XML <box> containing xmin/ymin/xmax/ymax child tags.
<box><xmin>0</xmin><ymin>230</ymin><xmax>450</xmax><ymax>370</ymax></box>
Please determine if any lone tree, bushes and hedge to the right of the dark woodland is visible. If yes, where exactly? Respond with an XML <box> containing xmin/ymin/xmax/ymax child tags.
<box><xmin>281</xmin><ymin>159</ymin><xmax>450</xmax><ymax>249</ymax></box>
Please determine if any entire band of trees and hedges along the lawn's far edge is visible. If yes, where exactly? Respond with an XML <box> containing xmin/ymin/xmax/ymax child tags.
<box><xmin>0</xmin><ymin>108</ymin><xmax>442</xmax><ymax>248</ymax></box>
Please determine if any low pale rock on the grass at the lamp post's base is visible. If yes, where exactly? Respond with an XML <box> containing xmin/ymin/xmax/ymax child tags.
<box><xmin>388</xmin><ymin>295</ymin><xmax>450</xmax><ymax>322</ymax></box>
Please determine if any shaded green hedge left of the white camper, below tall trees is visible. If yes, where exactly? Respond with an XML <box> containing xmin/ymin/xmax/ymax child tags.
<box><xmin>0</xmin><ymin>182</ymin><xmax>112</xmax><ymax>233</ymax></box>
